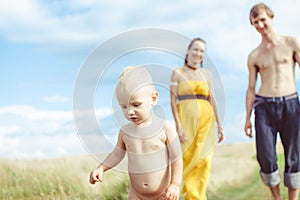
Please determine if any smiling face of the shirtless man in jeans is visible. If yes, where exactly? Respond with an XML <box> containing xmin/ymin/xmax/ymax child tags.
<box><xmin>251</xmin><ymin>10</ymin><xmax>272</xmax><ymax>35</ymax></box>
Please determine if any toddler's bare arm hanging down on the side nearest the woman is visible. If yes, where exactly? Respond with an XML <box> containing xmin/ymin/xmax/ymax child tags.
<box><xmin>162</xmin><ymin>122</ymin><xmax>183</xmax><ymax>199</ymax></box>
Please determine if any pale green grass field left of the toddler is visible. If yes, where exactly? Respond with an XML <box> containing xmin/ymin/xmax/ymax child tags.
<box><xmin>0</xmin><ymin>157</ymin><xmax>129</xmax><ymax>200</ymax></box>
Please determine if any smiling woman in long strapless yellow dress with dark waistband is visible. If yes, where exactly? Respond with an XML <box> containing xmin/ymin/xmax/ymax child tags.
<box><xmin>170</xmin><ymin>38</ymin><xmax>223</xmax><ymax>200</ymax></box>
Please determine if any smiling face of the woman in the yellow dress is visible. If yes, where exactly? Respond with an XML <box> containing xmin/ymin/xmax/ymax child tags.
<box><xmin>187</xmin><ymin>40</ymin><xmax>206</xmax><ymax>66</ymax></box>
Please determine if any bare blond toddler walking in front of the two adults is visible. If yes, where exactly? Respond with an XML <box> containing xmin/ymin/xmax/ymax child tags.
<box><xmin>90</xmin><ymin>67</ymin><xmax>183</xmax><ymax>200</ymax></box>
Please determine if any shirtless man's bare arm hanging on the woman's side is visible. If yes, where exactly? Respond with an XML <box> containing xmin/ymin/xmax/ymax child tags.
<box><xmin>244</xmin><ymin>54</ymin><xmax>257</xmax><ymax>138</ymax></box>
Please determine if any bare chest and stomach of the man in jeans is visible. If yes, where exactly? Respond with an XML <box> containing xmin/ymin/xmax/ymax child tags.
<box><xmin>252</xmin><ymin>36</ymin><xmax>296</xmax><ymax>97</ymax></box>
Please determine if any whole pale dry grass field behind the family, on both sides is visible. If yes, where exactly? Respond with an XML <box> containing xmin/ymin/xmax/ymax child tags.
<box><xmin>0</xmin><ymin>143</ymin><xmax>287</xmax><ymax>200</ymax></box>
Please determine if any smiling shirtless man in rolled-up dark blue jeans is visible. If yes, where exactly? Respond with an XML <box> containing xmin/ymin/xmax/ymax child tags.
<box><xmin>244</xmin><ymin>3</ymin><xmax>300</xmax><ymax>200</ymax></box>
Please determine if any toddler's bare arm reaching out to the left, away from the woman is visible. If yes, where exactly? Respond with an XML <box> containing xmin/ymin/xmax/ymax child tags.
<box><xmin>90</xmin><ymin>131</ymin><xmax>126</xmax><ymax>184</ymax></box>
